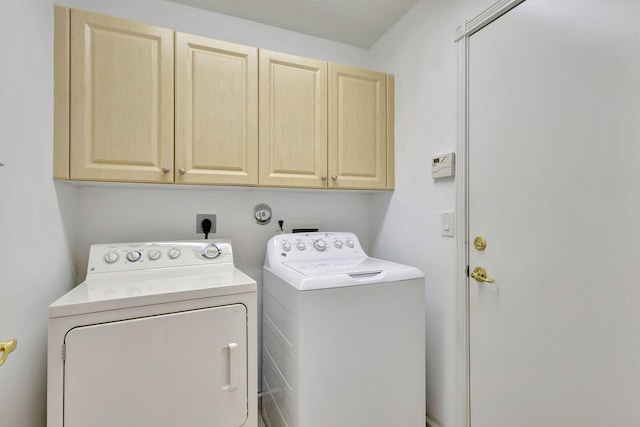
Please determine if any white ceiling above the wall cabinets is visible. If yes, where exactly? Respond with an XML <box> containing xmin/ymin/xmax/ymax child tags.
<box><xmin>164</xmin><ymin>0</ymin><xmax>419</xmax><ymax>49</ymax></box>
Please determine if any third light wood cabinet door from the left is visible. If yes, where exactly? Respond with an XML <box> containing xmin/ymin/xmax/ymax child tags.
<box><xmin>260</xmin><ymin>50</ymin><xmax>327</xmax><ymax>188</ymax></box>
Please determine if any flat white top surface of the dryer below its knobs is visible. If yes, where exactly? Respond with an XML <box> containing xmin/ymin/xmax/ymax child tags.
<box><xmin>49</xmin><ymin>263</ymin><xmax>256</xmax><ymax>318</ymax></box>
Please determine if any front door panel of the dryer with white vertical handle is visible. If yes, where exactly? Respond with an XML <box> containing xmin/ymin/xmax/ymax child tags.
<box><xmin>64</xmin><ymin>304</ymin><xmax>247</xmax><ymax>427</ymax></box>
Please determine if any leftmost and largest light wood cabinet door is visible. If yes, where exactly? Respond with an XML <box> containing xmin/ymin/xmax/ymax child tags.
<box><xmin>70</xmin><ymin>9</ymin><xmax>173</xmax><ymax>182</ymax></box>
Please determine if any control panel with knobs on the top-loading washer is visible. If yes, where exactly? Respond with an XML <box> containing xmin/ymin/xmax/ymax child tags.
<box><xmin>267</xmin><ymin>232</ymin><xmax>366</xmax><ymax>262</ymax></box>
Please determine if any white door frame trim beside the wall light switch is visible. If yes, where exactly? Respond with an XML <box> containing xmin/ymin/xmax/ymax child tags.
<box><xmin>455</xmin><ymin>0</ymin><xmax>525</xmax><ymax>427</ymax></box>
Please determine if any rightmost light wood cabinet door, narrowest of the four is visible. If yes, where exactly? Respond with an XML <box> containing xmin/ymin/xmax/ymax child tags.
<box><xmin>328</xmin><ymin>64</ymin><xmax>387</xmax><ymax>190</ymax></box>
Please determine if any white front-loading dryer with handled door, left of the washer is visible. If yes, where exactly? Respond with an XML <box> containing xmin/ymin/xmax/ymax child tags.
<box><xmin>47</xmin><ymin>240</ymin><xmax>258</xmax><ymax>427</ymax></box>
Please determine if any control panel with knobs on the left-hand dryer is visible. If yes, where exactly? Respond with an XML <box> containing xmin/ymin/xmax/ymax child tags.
<box><xmin>87</xmin><ymin>239</ymin><xmax>233</xmax><ymax>274</ymax></box>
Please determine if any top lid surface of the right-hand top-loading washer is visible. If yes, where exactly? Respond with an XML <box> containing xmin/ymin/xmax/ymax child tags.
<box><xmin>272</xmin><ymin>257</ymin><xmax>424</xmax><ymax>291</ymax></box>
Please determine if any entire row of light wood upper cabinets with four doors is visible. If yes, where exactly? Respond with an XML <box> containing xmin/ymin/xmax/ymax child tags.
<box><xmin>54</xmin><ymin>6</ymin><xmax>393</xmax><ymax>189</ymax></box>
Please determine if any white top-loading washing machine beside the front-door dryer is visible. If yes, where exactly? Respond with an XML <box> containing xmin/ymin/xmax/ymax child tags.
<box><xmin>262</xmin><ymin>232</ymin><xmax>426</xmax><ymax>427</ymax></box>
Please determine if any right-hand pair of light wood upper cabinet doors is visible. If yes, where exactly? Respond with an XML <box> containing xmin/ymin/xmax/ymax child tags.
<box><xmin>259</xmin><ymin>50</ymin><xmax>393</xmax><ymax>190</ymax></box>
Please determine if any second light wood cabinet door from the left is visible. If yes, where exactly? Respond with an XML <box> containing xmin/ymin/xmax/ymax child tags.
<box><xmin>175</xmin><ymin>33</ymin><xmax>258</xmax><ymax>185</ymax></box>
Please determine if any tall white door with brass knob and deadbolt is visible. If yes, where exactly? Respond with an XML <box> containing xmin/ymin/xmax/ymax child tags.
<box><xmin>468</xmin><ymin>0</ymin><xmax>640</xmax><ymax>427</ymax></box>
